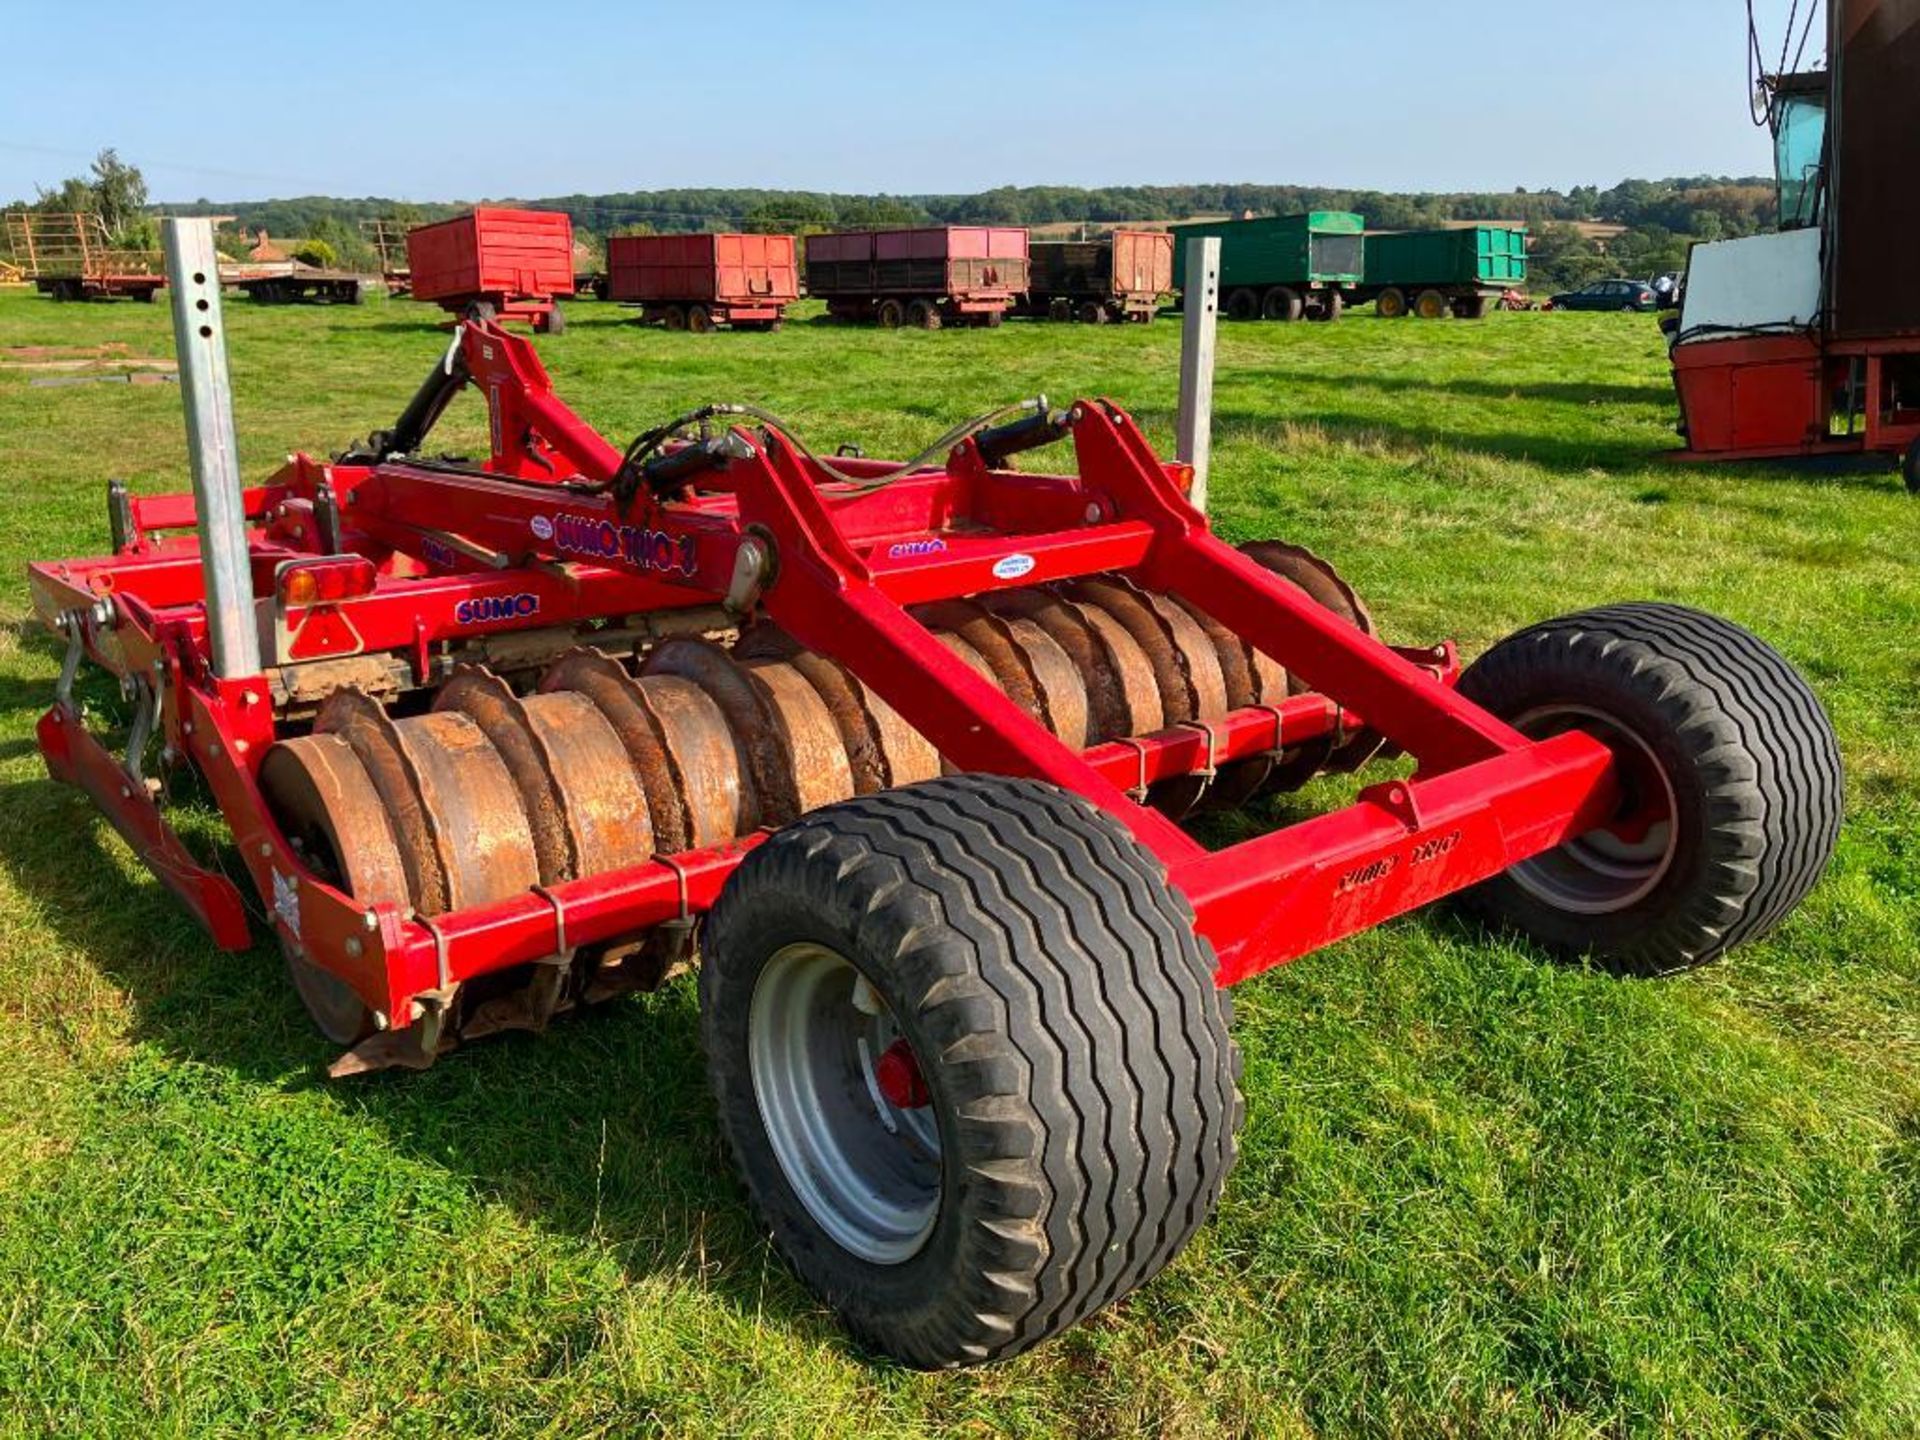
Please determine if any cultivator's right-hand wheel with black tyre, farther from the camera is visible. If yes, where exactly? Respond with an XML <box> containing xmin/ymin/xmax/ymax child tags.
<box><xmin>1459</xmin><ymin>603</ymin><xmax>1841</xmax><ymax>975</ymax></box>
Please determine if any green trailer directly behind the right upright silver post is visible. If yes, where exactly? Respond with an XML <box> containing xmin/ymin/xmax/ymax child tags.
<box><xmin>1171</xmin><ymin>209</ymin><xmax>1367</xmax><ymax>321</ymax></box>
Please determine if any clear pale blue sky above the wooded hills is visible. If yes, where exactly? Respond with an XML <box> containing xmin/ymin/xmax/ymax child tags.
<box><xmin>0</xmin><ymin>0</ymin><xmax>1818</xmax><ymax>200</ymax></box>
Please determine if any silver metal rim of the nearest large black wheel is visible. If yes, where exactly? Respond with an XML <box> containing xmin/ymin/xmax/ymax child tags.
<box><xmin>747</xmin><ymin>941</ymin><xmax>941</xmax><ymax>1265</ymax></box>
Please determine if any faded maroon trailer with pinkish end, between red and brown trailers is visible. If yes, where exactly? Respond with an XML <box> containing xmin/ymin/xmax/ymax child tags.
<box><xmin>806</xmin><ymin>225</ymin><xmax>1027</xmax><ymax>330</ymax></box>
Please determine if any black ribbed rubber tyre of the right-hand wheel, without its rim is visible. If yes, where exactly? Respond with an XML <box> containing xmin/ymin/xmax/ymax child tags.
<box><xmin>1459</xmin><ymin>603</ymin><xmax>1843</xmax><ymax>973</ymax></box>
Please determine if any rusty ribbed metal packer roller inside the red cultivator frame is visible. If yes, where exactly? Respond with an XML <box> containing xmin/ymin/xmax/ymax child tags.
<box><xmin>261</xmin><ymin>541</ymin><xmax>1377</xmax><ymax>1069</ymax></box>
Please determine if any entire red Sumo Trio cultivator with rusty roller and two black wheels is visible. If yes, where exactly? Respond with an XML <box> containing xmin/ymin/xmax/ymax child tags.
<box><xmin>22</xmin><ymin>311</ymin><xmax>1839</xmax><ymax>1367</ymax></box>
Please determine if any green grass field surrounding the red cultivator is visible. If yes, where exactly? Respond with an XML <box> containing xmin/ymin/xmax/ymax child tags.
<box><xmin>0</xmin><ymin>294</ymin><xmax>1920</xmax><ymax>1436</ymax></box>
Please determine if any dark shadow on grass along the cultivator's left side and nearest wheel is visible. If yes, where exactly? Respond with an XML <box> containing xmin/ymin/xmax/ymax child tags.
<box><xmin>0</xmin><ymin>780</ymin><xmax>817</xmax><ymax>1338</ymax></box>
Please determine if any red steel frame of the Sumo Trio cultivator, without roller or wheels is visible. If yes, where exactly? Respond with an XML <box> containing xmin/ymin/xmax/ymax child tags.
<box><xmin>31</xmin><ymin>323</ymin><xmax>1617</xmax><ymax>1023</ymax></box>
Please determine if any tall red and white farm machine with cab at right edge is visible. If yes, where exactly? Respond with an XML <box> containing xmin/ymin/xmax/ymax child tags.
<box><xmin>1672</xmin><ymin>0</ymin><xmax>1920</xmax><ymax>493</ymax></box>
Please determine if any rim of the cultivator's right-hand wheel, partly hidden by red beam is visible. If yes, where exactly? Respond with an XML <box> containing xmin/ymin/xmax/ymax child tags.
<box><xmin>1507</xmin><ymin>705</ymin><xmax>1680</xmax><ymax>916</ymax></box>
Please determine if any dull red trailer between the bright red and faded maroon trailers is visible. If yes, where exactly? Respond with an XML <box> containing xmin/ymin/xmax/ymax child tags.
<box><xmin>607</xmin><ymin>234</ymin><xmax>801</xmax><ymax>332</ymax></box>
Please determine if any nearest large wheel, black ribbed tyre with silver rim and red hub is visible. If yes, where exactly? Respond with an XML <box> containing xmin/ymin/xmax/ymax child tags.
<box><xmin>701</xmin><ymin>776</ymin><xmax>1240</xmax><ymax>1369</ymax></box>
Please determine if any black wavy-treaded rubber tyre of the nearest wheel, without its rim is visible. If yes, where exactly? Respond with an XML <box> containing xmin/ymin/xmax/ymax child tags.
<box><xmin>701</xmin><ymin>776</ymin><xmax>1240</xmax><ymax>1365</ymax></box>
